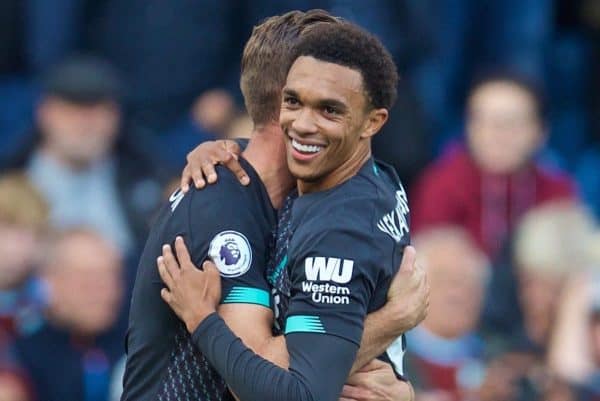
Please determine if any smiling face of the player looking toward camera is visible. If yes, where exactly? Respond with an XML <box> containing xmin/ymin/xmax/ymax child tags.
<box><xmin>280</xmin><ymin>56</ymin><xmax>387</xmax><ymax>192</ymax></box>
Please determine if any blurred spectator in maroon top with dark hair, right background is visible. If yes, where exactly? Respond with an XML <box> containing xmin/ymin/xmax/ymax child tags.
<box><xmin>411</xmin><ymin>73</ymin><xmax>575</xmax><ymax>259</ymax></box>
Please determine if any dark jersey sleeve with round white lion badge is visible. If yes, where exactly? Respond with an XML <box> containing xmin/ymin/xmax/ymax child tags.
<box><xmin>171</xmin><ymin>171</ymin><xmax>272</xmax><ymax>308</ymax></box>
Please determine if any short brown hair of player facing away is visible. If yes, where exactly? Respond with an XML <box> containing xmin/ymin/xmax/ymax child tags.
<box><xmin>240</xmin><ymin>9</ymin><xmax>341</xmax><ymax>125</ymax></box>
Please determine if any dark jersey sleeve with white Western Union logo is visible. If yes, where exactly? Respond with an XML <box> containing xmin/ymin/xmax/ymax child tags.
<box><xmin>285</xmin><ymin>221</ymin><xmax>386</xmax><ymax>345</ymax></box>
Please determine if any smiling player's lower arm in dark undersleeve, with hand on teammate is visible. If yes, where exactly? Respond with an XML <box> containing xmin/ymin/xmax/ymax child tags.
<box><xmin>159</xmin><ymin>250</ymin><xmax>358</xmax><ymax>401</ymax></box>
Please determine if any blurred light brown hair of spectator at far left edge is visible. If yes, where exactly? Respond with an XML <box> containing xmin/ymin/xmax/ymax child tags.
<box><xmin>0</xmin><ymin>172</ymin><xmax>49</xmax><ymax>231</ymax></box>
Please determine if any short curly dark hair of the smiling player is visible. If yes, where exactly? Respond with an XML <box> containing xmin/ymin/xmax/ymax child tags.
<box><xmin>294</xmin><ymin>21</ymin><xmax>398</xmax><ymax>110</ymax></box>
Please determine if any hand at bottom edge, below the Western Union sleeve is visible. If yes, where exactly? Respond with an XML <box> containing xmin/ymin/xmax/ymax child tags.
<box><xmin>340</xmin><ymin>359</ymin><xmax>414</xmax><ymax>401</ymax></box>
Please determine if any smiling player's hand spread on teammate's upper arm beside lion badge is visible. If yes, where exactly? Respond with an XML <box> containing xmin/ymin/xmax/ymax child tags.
<box><xmin>157</xmin><ymin>237</ymin><xmax>221</xmax><ymax>333</ymax></box>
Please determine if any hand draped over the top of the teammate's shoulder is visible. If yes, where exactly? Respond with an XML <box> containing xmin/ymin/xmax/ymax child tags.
<box><xmin>181</xmin><ymin>139</ymin><xmax>250</xmax><ymax>192</ymax></box>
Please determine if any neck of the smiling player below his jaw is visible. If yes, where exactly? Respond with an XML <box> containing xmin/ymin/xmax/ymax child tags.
<box><xmin>298</xmin><ymin>139</ymin><xmax>371</xmax><ymax>195</ymax></box>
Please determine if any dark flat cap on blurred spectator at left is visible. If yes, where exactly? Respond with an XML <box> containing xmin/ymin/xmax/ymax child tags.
<box><xmin>42</xmin><ymin>56</ymin><xmax>122</xmax><ymax>103</ymax></box>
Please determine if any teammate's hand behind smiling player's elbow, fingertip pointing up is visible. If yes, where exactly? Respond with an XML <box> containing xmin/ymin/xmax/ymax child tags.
<box><xmin>382</xmin><ymin>245</ymin><xmax>429</xmax><ymax>336</ymax></box>
